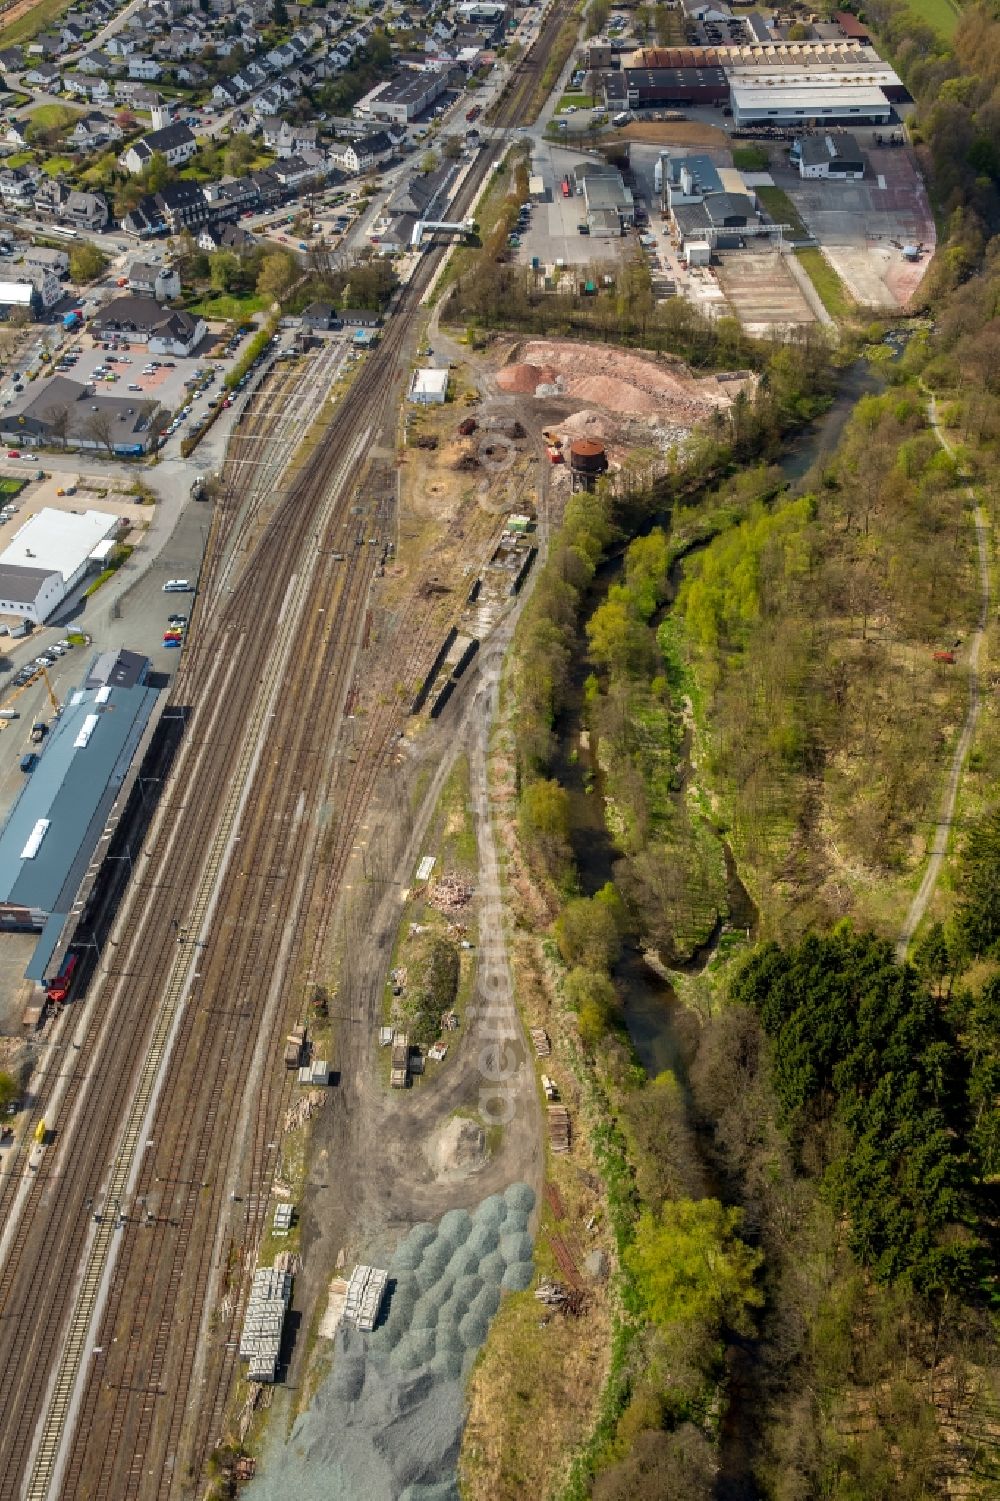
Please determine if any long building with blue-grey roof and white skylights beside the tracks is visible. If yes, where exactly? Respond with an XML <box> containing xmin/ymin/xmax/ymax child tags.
<box><xmin>0</xmin><ymin>650</ymin><xmax>161</xmax><ymax>982</ymax></box>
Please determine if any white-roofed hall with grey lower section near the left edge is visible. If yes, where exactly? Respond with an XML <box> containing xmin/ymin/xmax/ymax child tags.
<box><xmin>0</xmin><ymin>507</ymin><xmax>122</xmax><ymax>626</ymax></box>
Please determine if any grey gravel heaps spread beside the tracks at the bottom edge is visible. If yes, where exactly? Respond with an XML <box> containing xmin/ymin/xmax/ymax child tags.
<box><xmin>246</xmin><ymin>1183</ymin><xmax>535</xmax><ymax>1501</ymax></box>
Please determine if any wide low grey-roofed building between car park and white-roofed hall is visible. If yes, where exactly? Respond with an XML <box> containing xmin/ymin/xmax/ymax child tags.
<box><xmin>0</xmin><ymin>373</ymin><xmax>165</xmax><ymax>456</ymax></box>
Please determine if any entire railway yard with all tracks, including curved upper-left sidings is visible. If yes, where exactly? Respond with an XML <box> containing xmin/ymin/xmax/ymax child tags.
<box><xmin>0</xmin><ymin>5</ymin><xmax>568</xmax><ymax>1501</ymax></box>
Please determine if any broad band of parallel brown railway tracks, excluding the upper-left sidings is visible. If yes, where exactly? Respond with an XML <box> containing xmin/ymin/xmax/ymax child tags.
<box><xmin>0</xmin><ymin>6</ymin><xmax>569</xmax><ymax>1501</ymax></box>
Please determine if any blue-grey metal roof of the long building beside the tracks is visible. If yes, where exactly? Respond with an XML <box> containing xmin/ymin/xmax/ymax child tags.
<box><xmin>0</xmin><ymin>653</ymin><xmax>159</xmax><ymax>948</ymax></box>
